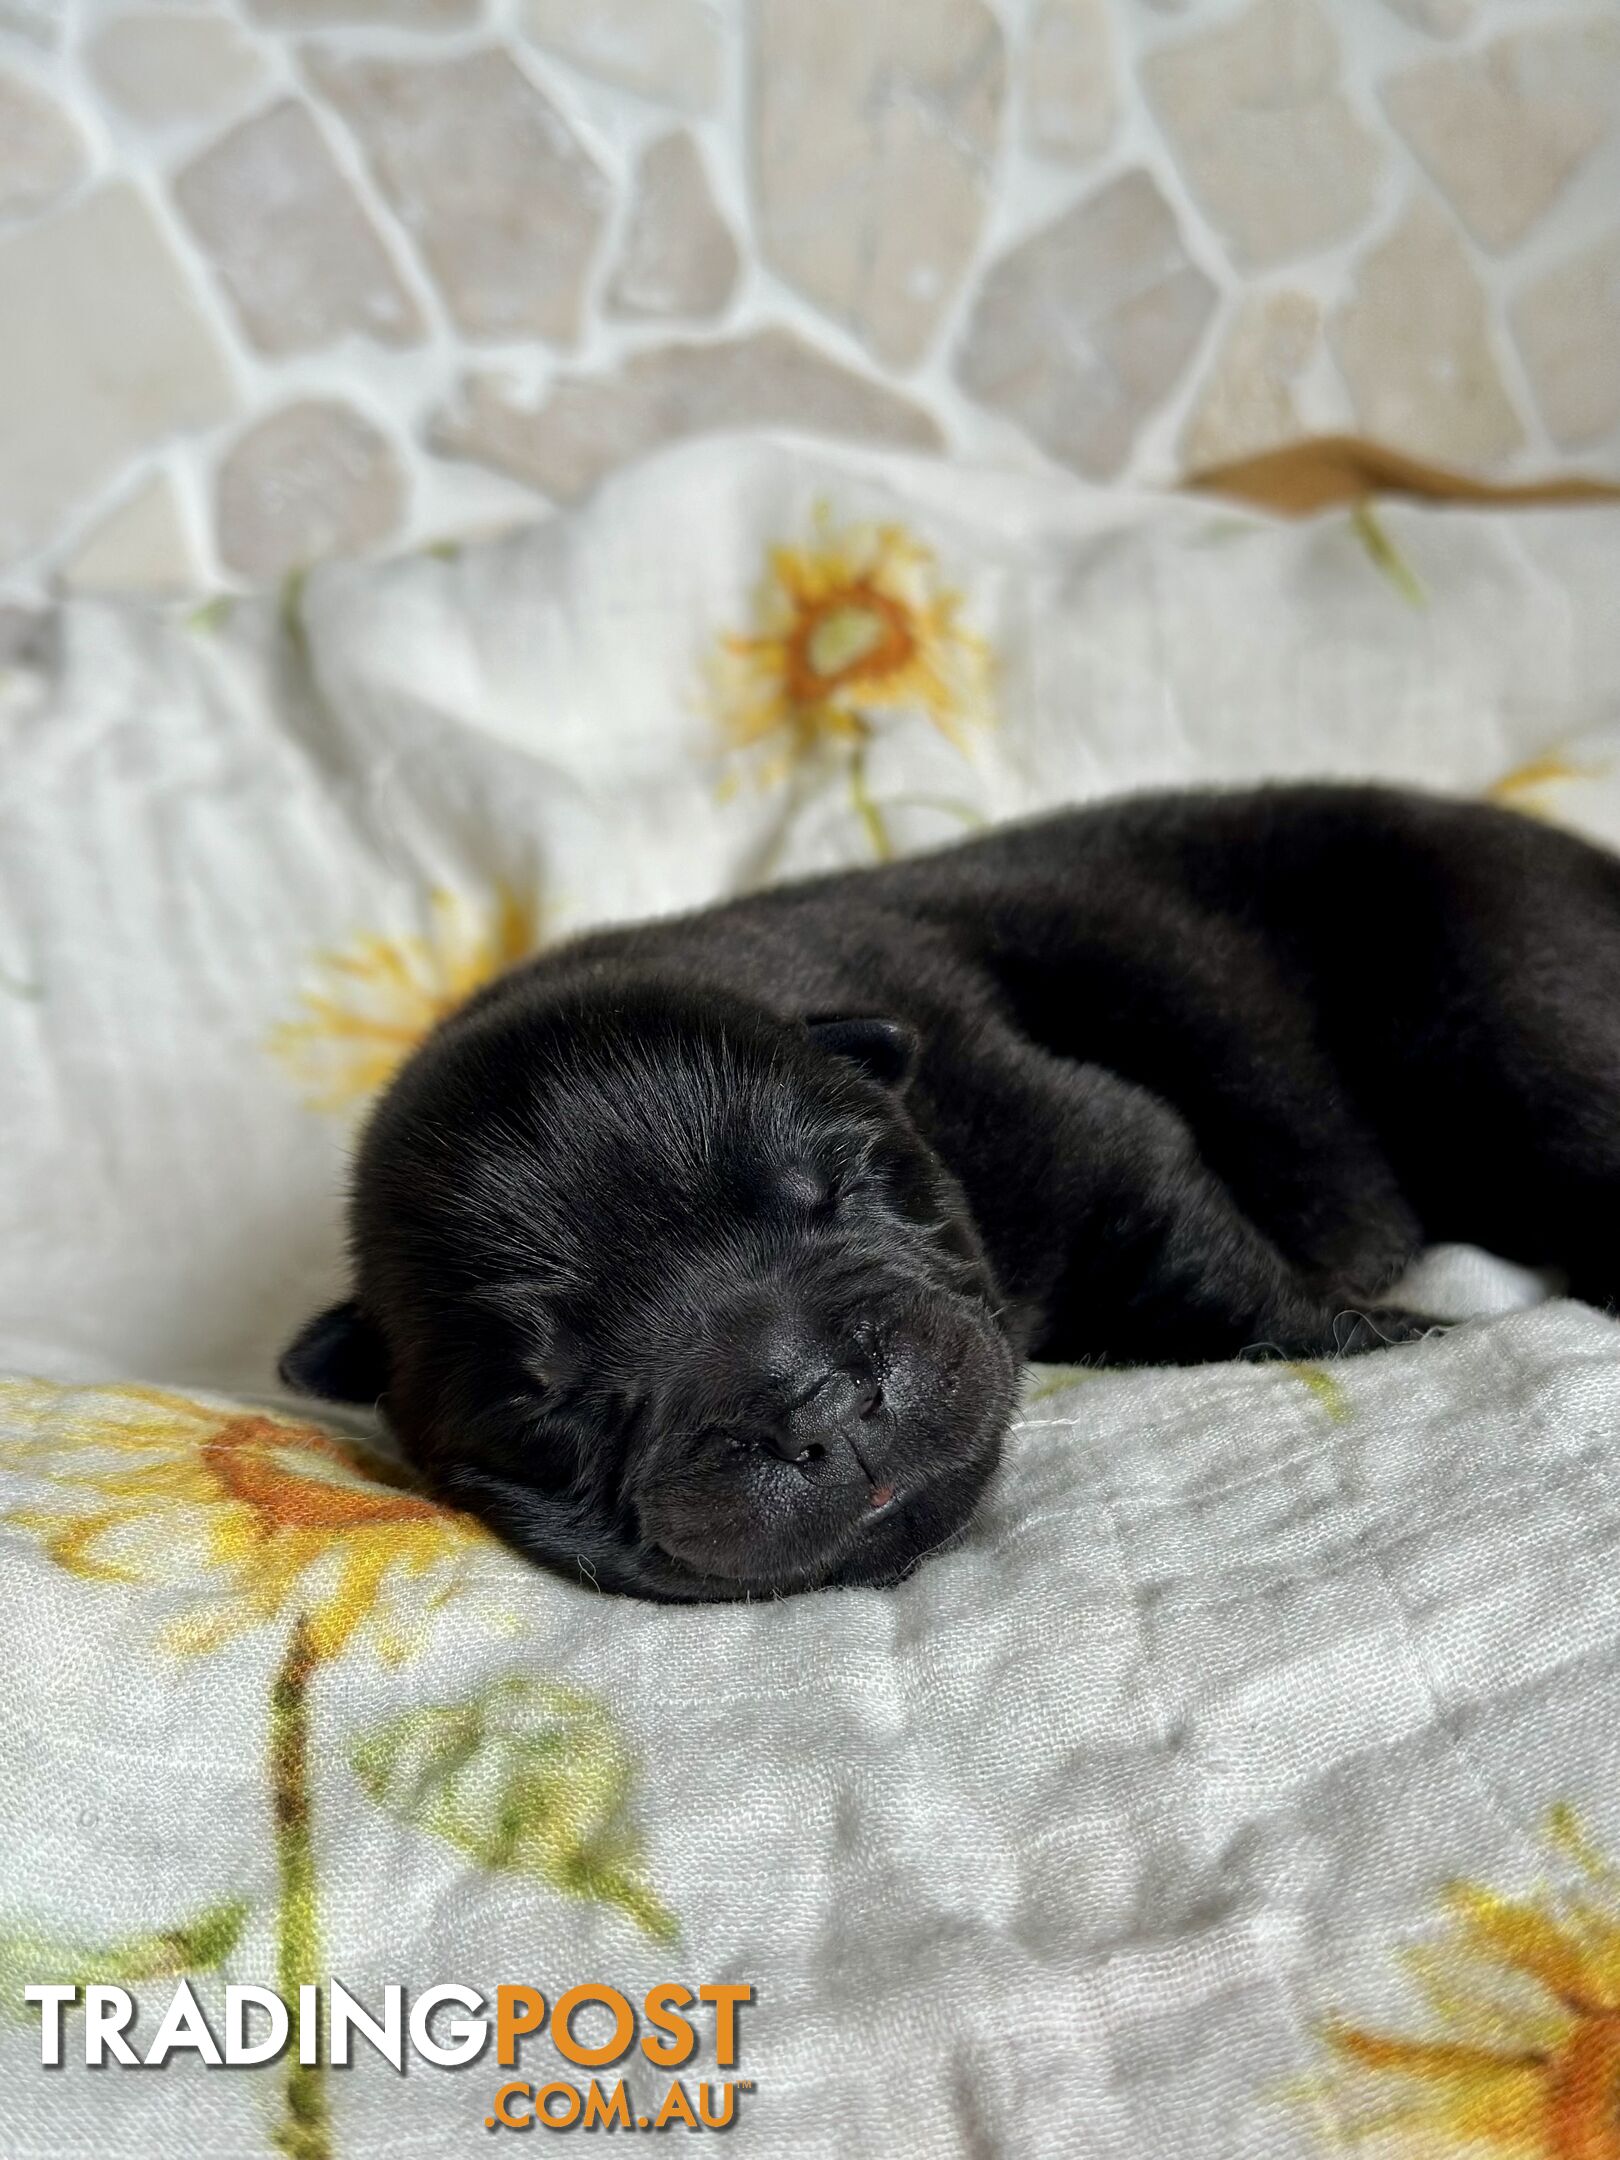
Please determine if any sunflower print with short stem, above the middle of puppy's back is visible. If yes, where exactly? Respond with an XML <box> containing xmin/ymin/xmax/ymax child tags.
<box><xmin>717</xmin><ymin>505</ymin><xmax>996</xmax><ymax>853</ymax></box>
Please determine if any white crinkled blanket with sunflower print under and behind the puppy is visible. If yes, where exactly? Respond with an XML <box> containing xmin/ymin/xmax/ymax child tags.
<box><xmin>0</xmin><ymin>441</ymin><xmax>1620</xmax><ymax>2160</ymax></box>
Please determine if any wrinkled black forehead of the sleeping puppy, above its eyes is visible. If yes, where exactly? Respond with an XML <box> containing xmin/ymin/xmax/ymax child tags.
<box><xmin>356</xmin><ymin>996</ymin><xmax>902</xmax><ymax>1296</ymax></box>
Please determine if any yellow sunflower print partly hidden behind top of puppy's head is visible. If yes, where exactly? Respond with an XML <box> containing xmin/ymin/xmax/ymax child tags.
<box><xmin>270</xmin><ymin>886</ymin><xmax>540</xmax><ymax>1110</ymax></box>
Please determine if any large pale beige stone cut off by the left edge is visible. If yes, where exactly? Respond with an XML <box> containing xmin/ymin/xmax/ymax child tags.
<box><xmin>0</xmin><ymin>184</ymin><xmax>235</xmax><ymax>564</ymax></box>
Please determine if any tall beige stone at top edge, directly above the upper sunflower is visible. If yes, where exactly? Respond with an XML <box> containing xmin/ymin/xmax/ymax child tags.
<box><xmin>754</xmin><ymin>0</ymin><xmax>1007</xmax><ymax>367</ymax></box>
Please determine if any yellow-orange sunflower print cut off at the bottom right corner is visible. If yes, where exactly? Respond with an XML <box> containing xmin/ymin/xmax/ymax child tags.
<box><xmin>1326</xmin><ymin>1808</ymin><xmax>1620</xmax><ymax>2160</ymax></box>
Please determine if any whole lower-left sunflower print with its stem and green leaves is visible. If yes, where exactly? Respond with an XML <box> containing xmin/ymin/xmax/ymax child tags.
<box><xmin>0</xmin><ymin>1380</ymin><xmax>674</xmax><ymax>2160</ymax></box>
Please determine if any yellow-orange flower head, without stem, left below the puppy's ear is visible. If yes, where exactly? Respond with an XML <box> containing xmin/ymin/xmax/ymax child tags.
<box><xmin>0</xmin><ymin>1382</ymin><xmax>492</xmax><ymax>1663</ymax></box>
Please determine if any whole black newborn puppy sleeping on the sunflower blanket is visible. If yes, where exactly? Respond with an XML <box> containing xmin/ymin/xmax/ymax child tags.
<box><xmin>283</xmin><ymin>786</ymin><xmax>1620</xmax><ymax>1598</ymax></box>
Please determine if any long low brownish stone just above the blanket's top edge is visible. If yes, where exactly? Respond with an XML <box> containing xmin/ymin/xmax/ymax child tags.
<box><xmin>430</xmin><ymin>330</ymin><xmax>942</xmax><ymax>503</ymax></box>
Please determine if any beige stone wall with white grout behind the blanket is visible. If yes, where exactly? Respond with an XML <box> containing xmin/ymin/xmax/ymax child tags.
<box><xmin>0</xmin><ymin>0</ymin><xmax>1620</xmax><ymax>594</ymax></box>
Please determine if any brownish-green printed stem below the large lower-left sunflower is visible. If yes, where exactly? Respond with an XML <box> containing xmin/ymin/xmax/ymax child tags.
<box><xmin>270</xmin><ymin>1614</ymin><xmax>333</xmax><ymax>2160</ymax></box>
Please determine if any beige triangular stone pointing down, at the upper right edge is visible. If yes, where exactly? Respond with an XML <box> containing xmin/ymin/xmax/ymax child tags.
<box><xmin>1385</xmin><ymin>17</ymin><xmax>1620</xmax><ymax>248</ymax></box>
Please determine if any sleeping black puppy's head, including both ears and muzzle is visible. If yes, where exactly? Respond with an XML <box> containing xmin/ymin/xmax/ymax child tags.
<box><xmin>283</xmin><ymin>978</ymin><xmax>1015</xmax><ymax>1598</ymax></box>
